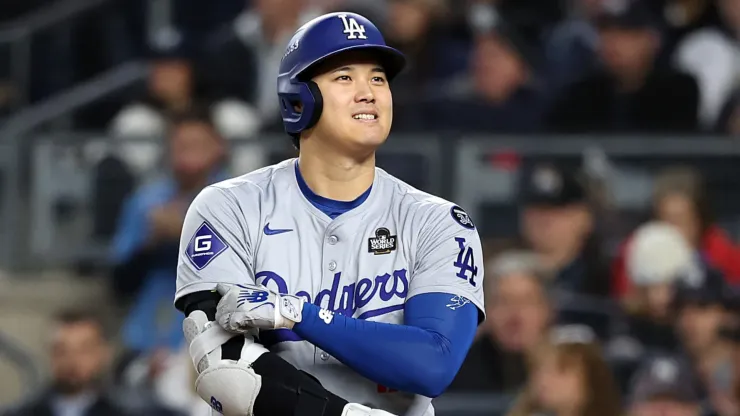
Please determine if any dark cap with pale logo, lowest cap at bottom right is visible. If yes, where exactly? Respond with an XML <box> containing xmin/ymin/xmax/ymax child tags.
<box><xmin>630</xmin><ymin>356</ymin><xmax>700</xmax><ymax>404</ymax></box>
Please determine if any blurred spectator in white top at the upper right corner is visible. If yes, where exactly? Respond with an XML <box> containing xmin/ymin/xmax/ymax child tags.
<box><xmin>674</xmin><ymin>0</ymin><xmax>740</xmax><ymax>131</ymax></box>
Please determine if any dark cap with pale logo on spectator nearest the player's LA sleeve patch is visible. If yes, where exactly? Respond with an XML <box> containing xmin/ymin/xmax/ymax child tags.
<box><xmin>521</xmin><ymin>165</ymin><xmax>587</xmax><ymax>206</ymax></box>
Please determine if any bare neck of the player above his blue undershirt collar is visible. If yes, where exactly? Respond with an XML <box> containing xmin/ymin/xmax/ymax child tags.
<box><xmin>298</xmin><ymin>140</ymin><xmax>375</xmax><ymax>201</ymax></box>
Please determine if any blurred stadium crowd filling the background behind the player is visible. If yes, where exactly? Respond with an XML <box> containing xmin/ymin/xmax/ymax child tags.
<box><xmin>0</xmin><ymin>0</ymin><xmax>740</xmax><ymax>416</ymax></box>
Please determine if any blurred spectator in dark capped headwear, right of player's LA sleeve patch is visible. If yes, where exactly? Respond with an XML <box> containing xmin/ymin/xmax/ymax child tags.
<box><xmin>521</xmin><ymin>164</ymin><xmax>610</xmax><ymax>297</ymax></box>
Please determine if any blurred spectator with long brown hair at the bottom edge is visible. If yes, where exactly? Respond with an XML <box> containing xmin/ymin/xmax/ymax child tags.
<box><xmin>507</xmin><ymin>325</ymin><xmax>621</xmax><ymax>416</ymax></box>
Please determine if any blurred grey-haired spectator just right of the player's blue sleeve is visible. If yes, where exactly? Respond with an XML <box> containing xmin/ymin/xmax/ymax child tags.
<box><xmin>449</xmin><ymin>251</ymin><xmax>552</xmax><ymax>393</ymax></box>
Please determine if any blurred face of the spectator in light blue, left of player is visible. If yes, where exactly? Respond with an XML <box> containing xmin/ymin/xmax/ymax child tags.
<box><xmin>169</xmin><ymin>121</ymin><xmax>224</xmax><ymax>184</ymax></box>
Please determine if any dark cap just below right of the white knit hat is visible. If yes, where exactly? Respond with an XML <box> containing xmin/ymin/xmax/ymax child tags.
<box><xmin>674</xmin><ymin>269</ymin><xmax>732</xmax><ymax>307</ymax></box>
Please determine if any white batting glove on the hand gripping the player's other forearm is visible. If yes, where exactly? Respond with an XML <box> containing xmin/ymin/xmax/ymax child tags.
<box><xmin>216</xmin><ymin>284</ymin><xmax>305</xmax><ymax>333</ymax></box>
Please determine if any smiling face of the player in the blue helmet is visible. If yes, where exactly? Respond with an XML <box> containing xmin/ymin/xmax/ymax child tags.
<box><xmin>310</xmin><ymin>52</ymin><xmax>393</xmax><ymax>151</ymax></box>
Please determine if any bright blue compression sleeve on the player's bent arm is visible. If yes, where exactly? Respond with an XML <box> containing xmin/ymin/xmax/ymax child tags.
<box><xmin>293</xmin><ymin>293</ymin><xmax>478</xmax><ymax>397</ymax></box>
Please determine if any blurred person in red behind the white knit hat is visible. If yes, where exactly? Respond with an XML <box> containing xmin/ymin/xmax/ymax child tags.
<box><xmin>612</xmin><ymin>167</ymin><xmax>740</xmax><ymax>298</ymax></box>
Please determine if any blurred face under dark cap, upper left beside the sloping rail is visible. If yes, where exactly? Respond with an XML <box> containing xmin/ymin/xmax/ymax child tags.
<box><xmin>149</xmin><ymin>59</ymin><xmax>193</xmax><ymax>105</ymax></box>
